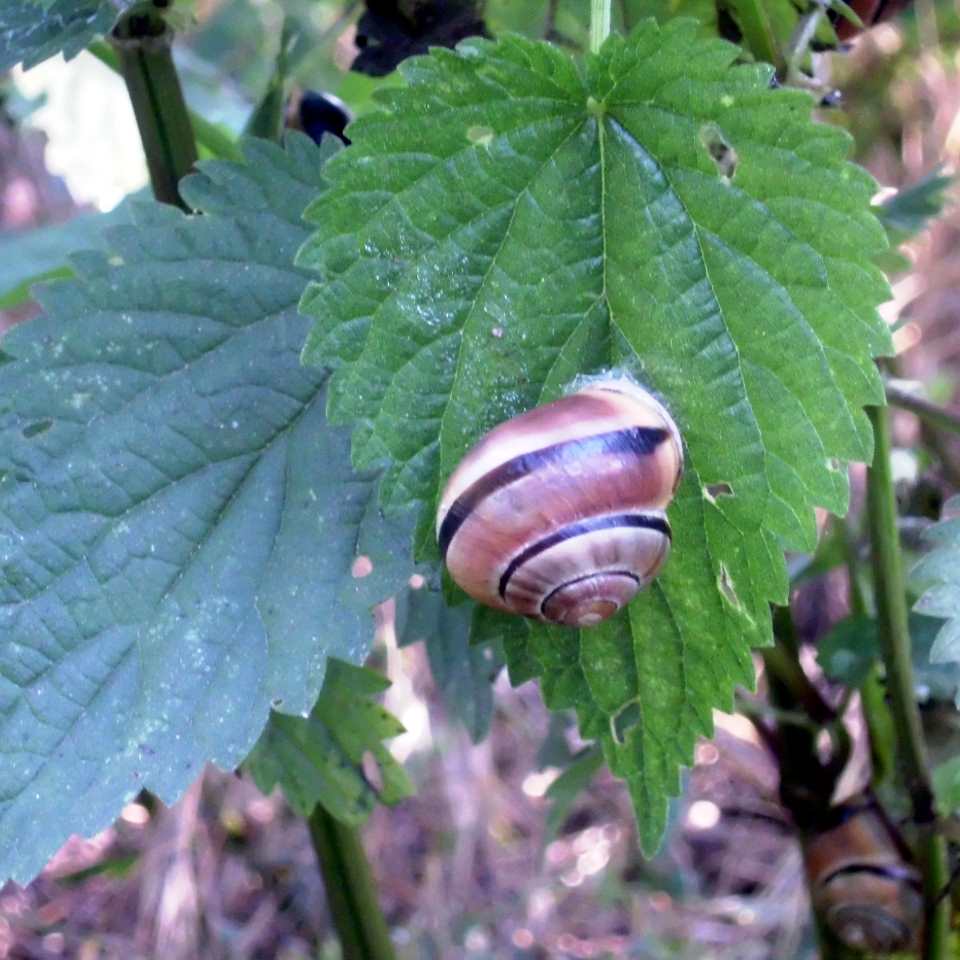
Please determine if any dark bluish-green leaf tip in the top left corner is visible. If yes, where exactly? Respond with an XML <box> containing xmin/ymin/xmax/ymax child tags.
<box><xmin>0</xmin><ymin>0</ymin><xmax>133</xmax><ymax>71</ymax></box>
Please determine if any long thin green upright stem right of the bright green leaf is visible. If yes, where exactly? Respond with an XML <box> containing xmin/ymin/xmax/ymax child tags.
<box><xmin>867</xmin><ymin>407</ymin><xmax>950</xmax><ymax>960</ymax></box>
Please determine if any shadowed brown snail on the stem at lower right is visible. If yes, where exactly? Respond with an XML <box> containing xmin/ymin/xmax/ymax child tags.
<box><xmin>803</xmin><ymin>794</ymin><xmax>923</xmax><ymax>953</ymax></box>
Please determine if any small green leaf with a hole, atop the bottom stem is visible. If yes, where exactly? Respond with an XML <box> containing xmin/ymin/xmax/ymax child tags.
<box><xmin>244</xmin><ymin>660</ymin><xmax>414</xmax><ymax>825</ymax></box>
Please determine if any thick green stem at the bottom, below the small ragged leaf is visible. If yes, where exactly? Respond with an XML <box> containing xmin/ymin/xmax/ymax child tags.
<box><xmin>309</xmin><ymin>804</ymin><xmax>395</xmax><ymax>960</ymax></box>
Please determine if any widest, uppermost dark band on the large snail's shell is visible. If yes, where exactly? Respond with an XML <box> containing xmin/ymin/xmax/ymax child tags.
<box><xmin>437</xmin><ymin>427</ymin><xmax>670</xmax><ymax>560</ymax></box>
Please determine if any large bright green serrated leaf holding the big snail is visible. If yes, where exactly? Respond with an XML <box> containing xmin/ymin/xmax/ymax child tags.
<box><xmin>300</xmin><ymin>20</ymin><xmax>891</xmax><ymax>850</ymax></box>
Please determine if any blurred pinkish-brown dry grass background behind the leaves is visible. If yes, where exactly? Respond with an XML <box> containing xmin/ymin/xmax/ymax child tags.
<box><xmin>0</xmin><ymin>0</ymin><xmax>960</xmax><ymax>960</ymax></box>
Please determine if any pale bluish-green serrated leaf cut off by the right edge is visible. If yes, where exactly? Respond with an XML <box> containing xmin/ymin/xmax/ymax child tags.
<box><xmin>911</xmin><ymin>497</ymin><xmax>960</xmax><ymax>706</ymax></box>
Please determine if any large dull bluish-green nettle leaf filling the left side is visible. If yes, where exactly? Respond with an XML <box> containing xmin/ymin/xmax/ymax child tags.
<box><xmin>0</xmin><ymin>135</ymin><xmax>411</xmax><ymax>880</ymax></box>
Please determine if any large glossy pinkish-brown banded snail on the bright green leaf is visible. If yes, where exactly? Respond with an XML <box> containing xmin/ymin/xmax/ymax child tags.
<box><xmin>437</xmin><ymin>379</ymin><xmax>683</xmax><ymax>627</ymax></box>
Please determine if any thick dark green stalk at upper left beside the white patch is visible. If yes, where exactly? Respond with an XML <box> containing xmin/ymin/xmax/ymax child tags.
<box><xmin>111</xmin><ymin>12</ymin><xmax>197</xmax><ymax>210</ymax></box>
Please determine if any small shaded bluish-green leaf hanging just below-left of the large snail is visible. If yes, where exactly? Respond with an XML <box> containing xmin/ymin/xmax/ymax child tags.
<box><xmin>397</xmin><ymin>586</ymin><xmax>503</xmax><ymax>743</ymax></box>
